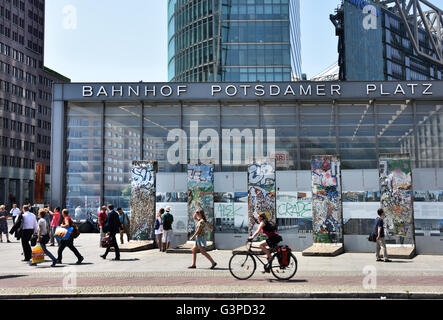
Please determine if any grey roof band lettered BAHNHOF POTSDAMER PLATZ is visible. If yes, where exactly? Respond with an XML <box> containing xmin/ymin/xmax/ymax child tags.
<box><xmin>59</xmin><ymin>81</ymin><xmax>443</xmax><ymax>100</ymax></box>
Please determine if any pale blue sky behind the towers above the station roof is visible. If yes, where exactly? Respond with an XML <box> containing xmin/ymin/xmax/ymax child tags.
<box><xmin>45</xmin><ymin>0</ymin><xmax>443</xmax><ymax>82</ymax></box>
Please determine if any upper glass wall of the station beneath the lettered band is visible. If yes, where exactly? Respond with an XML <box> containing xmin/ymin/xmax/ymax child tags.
<box><xmin>66</xmin><ymin>100</ymin><xmax>443</xmax><ymax>213</ymax></box>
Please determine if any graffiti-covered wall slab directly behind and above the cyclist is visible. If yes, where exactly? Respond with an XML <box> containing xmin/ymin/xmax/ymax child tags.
<box><xmin>248</xmin><ymin>159</ymin><xmax>277</xmax><ymax>234</ymax></box>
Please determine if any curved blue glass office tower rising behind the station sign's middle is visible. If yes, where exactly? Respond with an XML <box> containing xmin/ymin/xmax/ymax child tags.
<box><xmin>168</xmin><ymin>0</ymin><xmax>301</xmax><ymax>82</ymax></box>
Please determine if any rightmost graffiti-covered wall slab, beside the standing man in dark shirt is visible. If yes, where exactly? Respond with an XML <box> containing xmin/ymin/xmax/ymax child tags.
<box><xmin>380</xmin><ymin>155</ymin><xmax>415</xmax><ymax>244</ymax></box>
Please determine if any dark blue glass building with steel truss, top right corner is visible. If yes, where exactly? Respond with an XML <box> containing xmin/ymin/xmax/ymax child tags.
<box><xmin>331</xmin><ymin>1</ymin><xmax>443</xmax><ymax>81</ymax></box>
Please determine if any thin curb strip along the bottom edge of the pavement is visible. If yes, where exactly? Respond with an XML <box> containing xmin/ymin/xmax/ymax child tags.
<box><xmin>0</xmin><ymin>292</ymin><xmax>443</xmax><ymax>300</ymax></box>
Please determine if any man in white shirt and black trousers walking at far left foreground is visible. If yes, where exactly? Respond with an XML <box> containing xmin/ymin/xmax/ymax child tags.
<box><xmin>13</xmin><ymin>206</ymin><xmax>38</xmax><ymax>262</ymax></box>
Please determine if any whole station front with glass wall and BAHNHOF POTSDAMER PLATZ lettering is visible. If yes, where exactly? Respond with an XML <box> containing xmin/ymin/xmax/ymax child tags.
<box><xmin>51</xmin><ymin>81</ymin><xmax>443</xmax><ymax>254</ymax></box>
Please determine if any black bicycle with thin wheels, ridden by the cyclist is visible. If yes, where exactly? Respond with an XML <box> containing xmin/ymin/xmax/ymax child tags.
<box><xmin>229</xmin><ymin>240</ymin><xmax>297</xmax><ymax>280</ymax></box>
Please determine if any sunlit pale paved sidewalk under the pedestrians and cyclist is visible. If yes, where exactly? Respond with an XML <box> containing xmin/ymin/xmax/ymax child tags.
<box><xmin>0</xmin><ymin>221</ymin><xmax>443</xmax><ymax>298</ymax></box>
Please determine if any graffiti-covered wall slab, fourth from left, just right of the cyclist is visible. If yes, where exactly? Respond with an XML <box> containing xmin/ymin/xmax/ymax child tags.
<box><xmin>311</xmin><ymin>156</ymin><xmax>343</xmax><ymax>243</ymax></box>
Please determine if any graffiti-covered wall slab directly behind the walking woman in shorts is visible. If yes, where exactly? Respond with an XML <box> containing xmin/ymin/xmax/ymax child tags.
<box><xmin>187</xmin><ymin>164</ymin><xmax>214</xmax><ymax>241</ymax></box>
